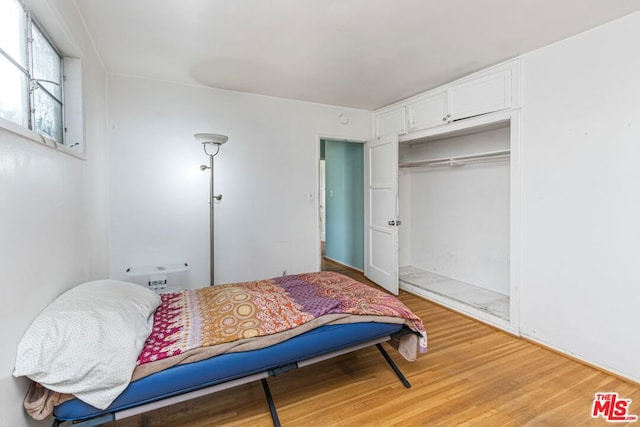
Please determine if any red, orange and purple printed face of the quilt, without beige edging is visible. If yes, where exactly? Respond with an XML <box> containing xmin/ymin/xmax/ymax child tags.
<box><xmin>138</xmin><ymin>272</ymin><xmax>426</xmax><ymax>365</ymax></box>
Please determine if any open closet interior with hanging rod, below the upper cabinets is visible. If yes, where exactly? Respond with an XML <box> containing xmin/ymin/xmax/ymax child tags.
<box><xmin>398</xmin><ymin>120</ymin><xmax>512</xmax><ymax>322</ymax></box>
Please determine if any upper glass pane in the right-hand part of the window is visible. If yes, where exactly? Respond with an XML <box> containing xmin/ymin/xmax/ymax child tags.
<box><xmin>32</xmin><ymin>25</ymin><xmax>62</xmax><ymax>101</ymax></box>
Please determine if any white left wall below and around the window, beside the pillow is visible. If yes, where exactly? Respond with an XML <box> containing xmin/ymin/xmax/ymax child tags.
<box><xmin>0</xmin><ymin>0</ymin><xmax>108</xmax><ymax>427</ymax></box>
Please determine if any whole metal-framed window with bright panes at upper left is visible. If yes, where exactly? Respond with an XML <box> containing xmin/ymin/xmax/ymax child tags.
<box><xmin>0</xmin><ymin>0</ymin><xmax>67</xmax><ymax>145</ymax></box>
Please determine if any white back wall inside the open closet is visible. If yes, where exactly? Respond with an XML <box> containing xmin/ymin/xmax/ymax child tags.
<box><xmin>400</xmin><ymin>127</ymin><xmax>510</xmax><ymax>295</ymax></box>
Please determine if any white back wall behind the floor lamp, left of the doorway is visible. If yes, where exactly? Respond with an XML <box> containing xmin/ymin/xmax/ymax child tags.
<box><xmin>108</xmin><ymin>75</ymin><xmax>371</xmax><ymax>288</ymax></box>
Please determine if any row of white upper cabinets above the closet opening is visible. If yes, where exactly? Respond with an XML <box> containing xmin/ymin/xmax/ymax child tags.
<box><xmin>374</xmin><ymin>60</ymin><xmax>519</xmax><ymax>136</ymax></box>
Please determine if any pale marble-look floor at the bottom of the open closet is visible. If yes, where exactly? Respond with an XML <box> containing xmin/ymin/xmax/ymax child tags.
<box><xmin>399</xmin><ymin>266</ymin><xmax>509</xmax><ymax>320</ymax></box>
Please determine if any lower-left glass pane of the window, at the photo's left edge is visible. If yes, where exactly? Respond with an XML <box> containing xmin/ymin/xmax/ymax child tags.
<box><xmin>0</xmin><ymin>55</ymin><xmax>29</xmax><ymax>127</ymax></box>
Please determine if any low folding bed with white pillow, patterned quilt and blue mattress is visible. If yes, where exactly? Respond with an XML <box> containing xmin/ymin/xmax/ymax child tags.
<box><xmin>14</xmin><ymin>272</ymin><xmax>426</xmax><ymax>426</ymax></box>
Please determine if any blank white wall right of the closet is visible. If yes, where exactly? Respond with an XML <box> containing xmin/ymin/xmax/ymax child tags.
<box><xmin>521</xmin><ymin>13</ymin><xmax>640</xmax><ymax>381</ymax></box>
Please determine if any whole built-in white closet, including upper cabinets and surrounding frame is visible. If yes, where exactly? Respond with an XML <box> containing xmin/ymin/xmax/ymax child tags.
<box><xmin>365</xmin><ymin>63</ymin><xmax>520</xmax><ymax>333</ymax></box>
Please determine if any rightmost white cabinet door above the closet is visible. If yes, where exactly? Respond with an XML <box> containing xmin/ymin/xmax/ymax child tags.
<box><xmin>447</xmin><ymin>70</ymin><xmax>511</xmax><ymax>121</ymax></box>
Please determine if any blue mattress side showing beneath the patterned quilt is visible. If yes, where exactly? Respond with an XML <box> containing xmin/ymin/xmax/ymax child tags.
<box><xmin>53</xmin><ymin>322</ymin><xmax>402</xmax><ymax>421</ymax></box>
